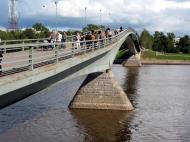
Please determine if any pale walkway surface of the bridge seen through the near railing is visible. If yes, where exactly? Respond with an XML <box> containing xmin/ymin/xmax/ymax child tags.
<box><xmin>0</xmin><ymin>48</ymin><xmax>98</xmax><ymax>78</ymax></box>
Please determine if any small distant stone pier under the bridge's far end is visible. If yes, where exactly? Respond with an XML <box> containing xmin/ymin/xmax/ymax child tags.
<box><xmin>122</xmin><ymin>53</ymin><xmax>142</xmax><ymax>67</ymax></box>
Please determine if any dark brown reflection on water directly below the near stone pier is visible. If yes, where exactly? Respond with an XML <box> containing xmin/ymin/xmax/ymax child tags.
<box><xmin>72</xmin><ymin>109</ymin><xmax>134</xmax><ymax>142</ymax></box>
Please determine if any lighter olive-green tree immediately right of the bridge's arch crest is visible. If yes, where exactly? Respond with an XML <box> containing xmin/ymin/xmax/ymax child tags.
<box><xmin>140</xmin><ymin>29</ymin><xmax>153</xmax><ymax>49</ymax></box>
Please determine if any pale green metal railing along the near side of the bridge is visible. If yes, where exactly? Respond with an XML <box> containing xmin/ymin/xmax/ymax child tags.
<box><xmin>0</xmin><ymin>30</ymin><xmax>127</xmax><ymax>74</ymax></box>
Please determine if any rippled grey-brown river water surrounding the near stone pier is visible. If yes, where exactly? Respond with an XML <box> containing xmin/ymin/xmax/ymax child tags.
<box><xmin>0</xmin><ymin>65</ymin><xmax>190</xmax><ymax>142</ymax></box>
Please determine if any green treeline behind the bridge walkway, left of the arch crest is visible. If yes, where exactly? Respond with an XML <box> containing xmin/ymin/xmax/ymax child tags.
<box><xmin>0</xmin><ymin>23</ymin><xmax>105</xmax><ymax>40</ymax></box>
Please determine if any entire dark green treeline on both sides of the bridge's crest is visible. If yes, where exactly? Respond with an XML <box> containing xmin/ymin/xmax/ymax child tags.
<box><xmin>0</xmin><ymin>23</ymin><xmax>190</xmax><ymax>53</ymax></box>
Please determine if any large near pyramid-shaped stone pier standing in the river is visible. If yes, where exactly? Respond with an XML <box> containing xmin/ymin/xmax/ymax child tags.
<box><xmin>70</xmin><ymin>70</ymin><xmax>133</xmax><ymax>110</ymax></box>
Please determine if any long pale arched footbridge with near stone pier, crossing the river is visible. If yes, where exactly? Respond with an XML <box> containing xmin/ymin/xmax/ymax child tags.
<box><xmin>0</xmin><ymin>28</ymin><xmax>141</xmax><ymax>110</ymax></box>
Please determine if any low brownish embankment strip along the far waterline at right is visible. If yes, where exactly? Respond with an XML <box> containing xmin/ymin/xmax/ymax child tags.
<box><xmin>141</xmin><ymin>59</ymin><xmax>190</xmax><ymax>65</ymax></box>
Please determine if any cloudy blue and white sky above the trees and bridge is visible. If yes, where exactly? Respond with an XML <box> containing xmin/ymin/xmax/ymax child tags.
<box><xmin>0</xmin><ymin>0</ymin><xmax>190</xmax><ymax>35</ymax></box>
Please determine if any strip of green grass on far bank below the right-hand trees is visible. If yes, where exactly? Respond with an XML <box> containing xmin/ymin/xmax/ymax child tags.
<box><xmin>141</xmin><ymin>50</ymin><xmax>190</xmax><ymax>60</ymax></box>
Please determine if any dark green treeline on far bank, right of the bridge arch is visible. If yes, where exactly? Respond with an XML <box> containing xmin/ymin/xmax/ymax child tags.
<box><xmin>140</xmin><ymin>29</ymin><xmax>190</xmax><ymax>53</ymax></box>
